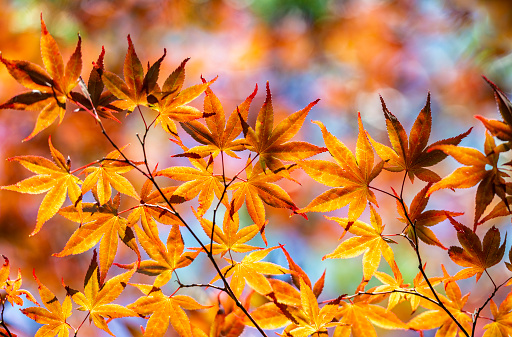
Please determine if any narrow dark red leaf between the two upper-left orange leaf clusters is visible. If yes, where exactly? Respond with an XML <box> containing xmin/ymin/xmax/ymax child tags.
<box><xmin>70</xmin><ymin>47</ymin><xmax>122</xmax><ymax>122</ymax></box>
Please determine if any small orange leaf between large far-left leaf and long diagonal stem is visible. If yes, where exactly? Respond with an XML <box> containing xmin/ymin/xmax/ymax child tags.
<box><xmin>82</xmin><ymin>146</ymin><xmax>140</xmax><ymax>205</ymax></box>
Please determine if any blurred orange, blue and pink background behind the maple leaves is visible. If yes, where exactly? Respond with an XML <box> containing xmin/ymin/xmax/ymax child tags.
<box><xmin>0</xmin><ymin>0</ymin><xmax>512</xmax><ymax>336</ymax></box>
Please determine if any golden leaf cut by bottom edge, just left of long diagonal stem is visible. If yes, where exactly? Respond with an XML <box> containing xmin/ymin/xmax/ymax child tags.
<box><xmin>128</xmin><ymin>286</ymin><xmax>209</xmax><ymax>337</ymax></box>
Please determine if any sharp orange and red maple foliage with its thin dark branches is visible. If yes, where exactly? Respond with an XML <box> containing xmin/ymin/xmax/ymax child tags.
<box><xmin>0</xmin><ymin>17</ymin><xmax>512</xmax><ymax>337</ymax></box>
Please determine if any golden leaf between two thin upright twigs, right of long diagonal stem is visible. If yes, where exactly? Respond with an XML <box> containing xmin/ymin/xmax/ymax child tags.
<box><xmin>156</xmin><ymin>158</ymin><xmax>227</xmax><ymax>215</ymax></box>
